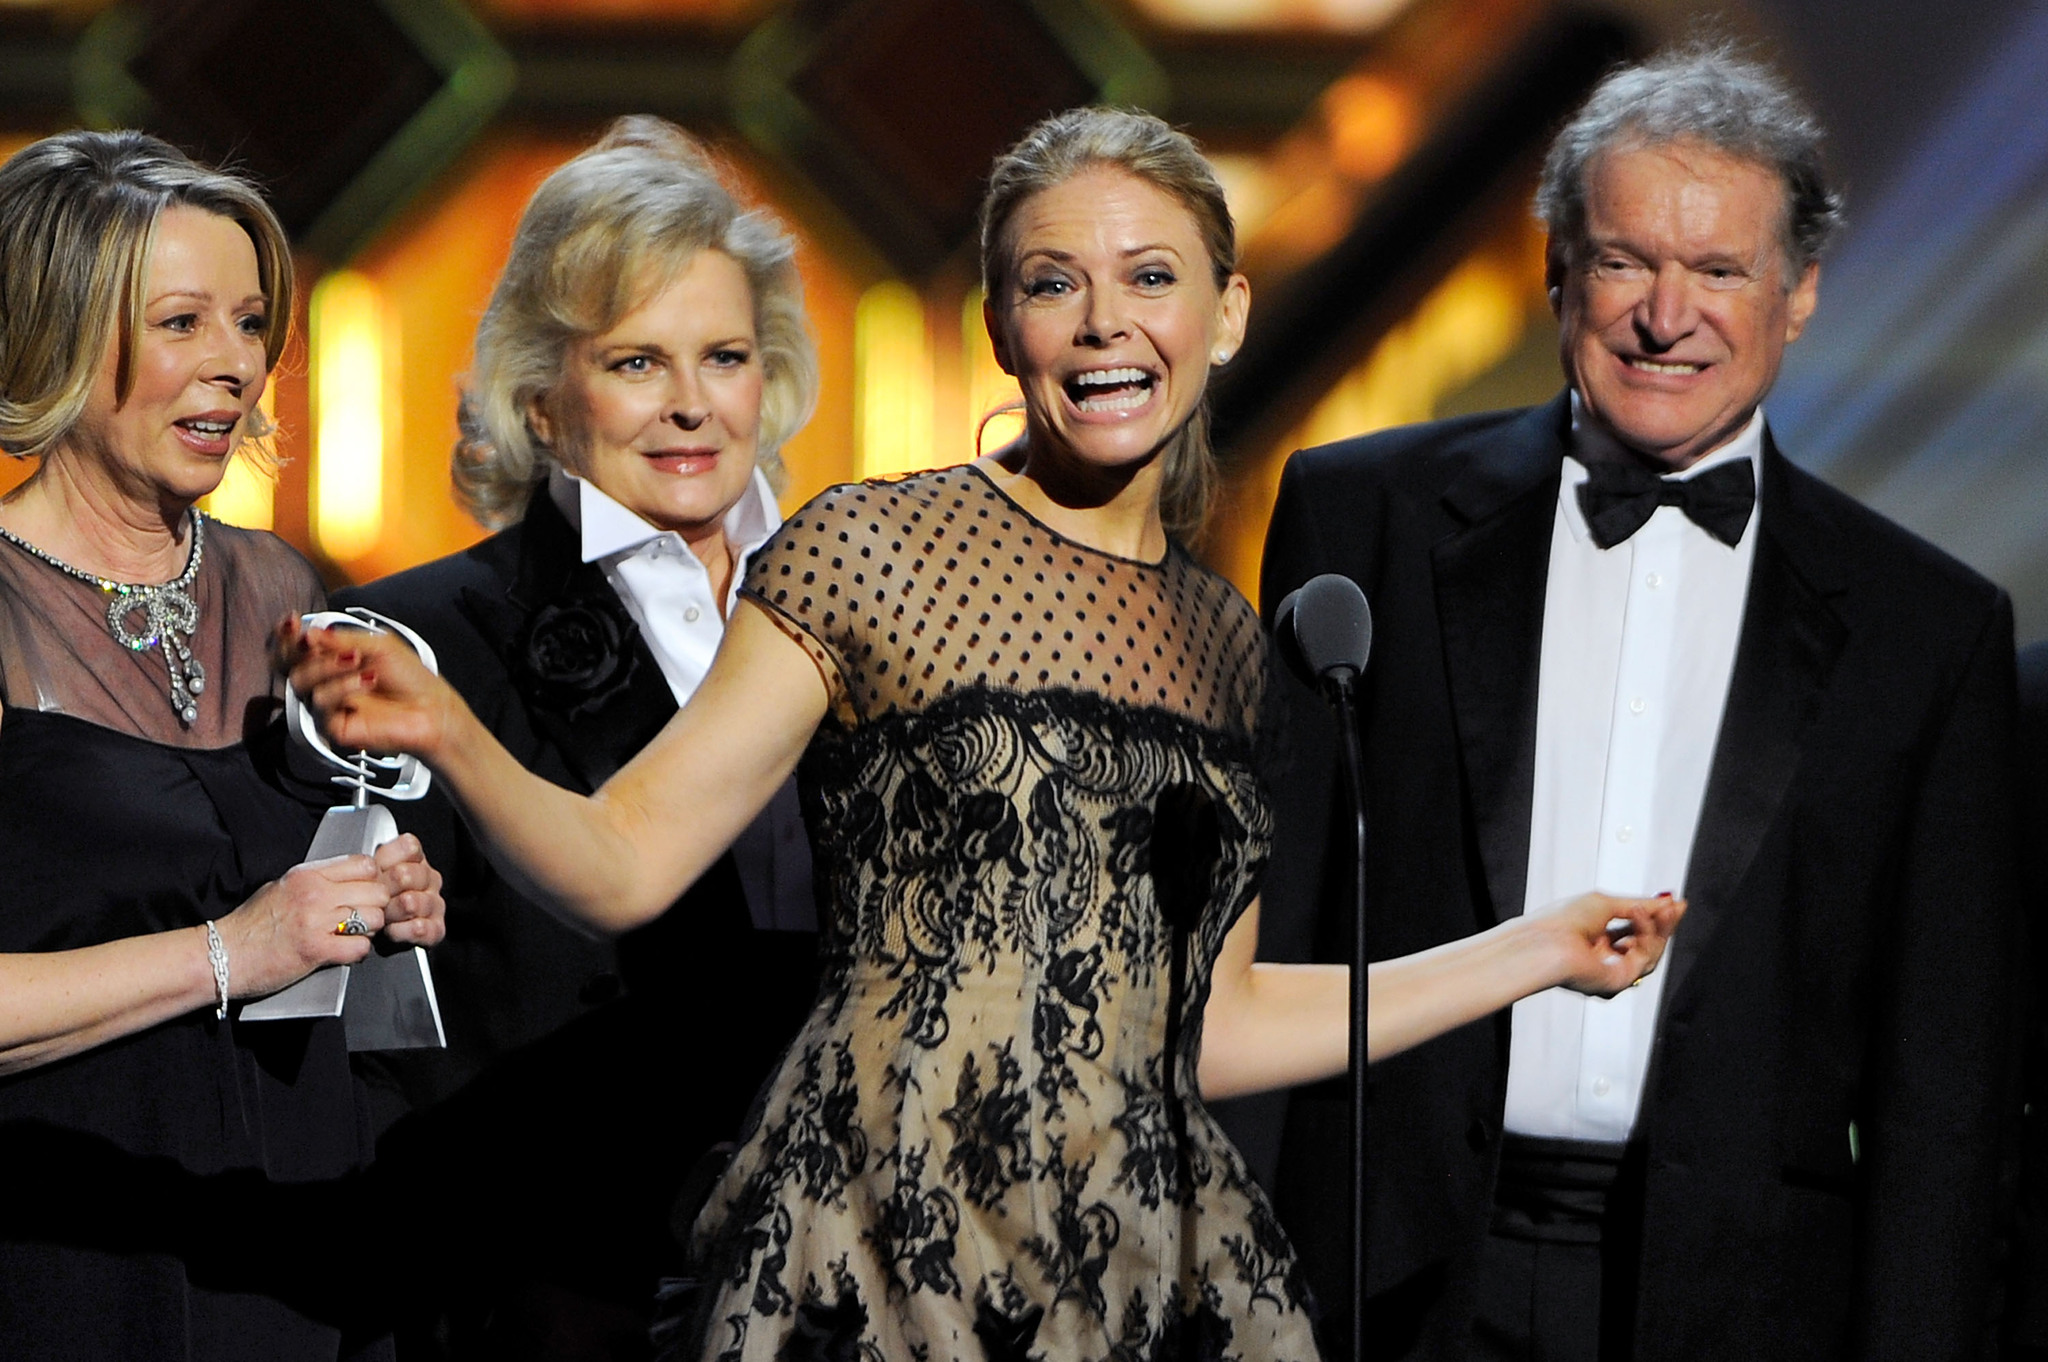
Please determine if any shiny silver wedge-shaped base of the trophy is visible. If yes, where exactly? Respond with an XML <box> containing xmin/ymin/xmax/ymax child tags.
<box><xmin>240</xmin><ymin>805</ymin><xmax>449</xmax><ymax>1051</ymax></box>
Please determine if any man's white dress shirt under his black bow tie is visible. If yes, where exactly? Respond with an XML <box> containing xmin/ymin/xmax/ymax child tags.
<box><xmin>1505</xmin><ymin>395</ymin><xmax>1763</xmax><ymax>1141</ymax></box>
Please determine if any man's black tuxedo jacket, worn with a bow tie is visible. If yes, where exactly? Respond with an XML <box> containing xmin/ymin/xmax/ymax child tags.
<box><xmin>1262</xmin><ymin>397</ymin><xmax>2015</xmax><ymax>1362</ymax></box>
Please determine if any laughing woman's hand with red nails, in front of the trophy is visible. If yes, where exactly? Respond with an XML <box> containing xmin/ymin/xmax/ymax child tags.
<box><xmin>276</xmin><ymin>616</ymin><xmax>461</xmax><ymax>766</ymax></box>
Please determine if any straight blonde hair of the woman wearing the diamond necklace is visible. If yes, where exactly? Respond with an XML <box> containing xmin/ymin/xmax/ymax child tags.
<box><xmin>0</xmin><ymin>129</ymin><xmax>293</xmax><ymax>457</ymax></box>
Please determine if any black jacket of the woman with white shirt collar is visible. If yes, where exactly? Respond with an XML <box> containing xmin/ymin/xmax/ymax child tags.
<box><xmin>334</xmin><ymin>494</ymin><xmax>817</xmax><ymax>1348</ymax></box>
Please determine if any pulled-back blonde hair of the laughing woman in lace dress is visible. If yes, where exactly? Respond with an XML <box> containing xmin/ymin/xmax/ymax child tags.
<box><xmin>981</xmin><ymin>109</ymin><xmax>1237</xmax><ymax>539</ymax></box>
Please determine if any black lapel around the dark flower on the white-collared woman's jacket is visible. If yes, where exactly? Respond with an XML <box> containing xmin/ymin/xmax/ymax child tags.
<box><xmin>461</xmin><ymin>487</ymin><xmax>676</xmax><ymax>791</ymax></box>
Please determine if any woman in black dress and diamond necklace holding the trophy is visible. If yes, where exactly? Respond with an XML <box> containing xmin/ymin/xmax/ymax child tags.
<box><xmin>0</xmin><ymin>133</ymin><xmax>442</xmax><ymax>1362</ymax></box>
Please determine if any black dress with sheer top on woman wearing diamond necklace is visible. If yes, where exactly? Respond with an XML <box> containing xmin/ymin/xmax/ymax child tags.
<box><xmin>0</xmin><ymin>522</ymin><xmax>389</xmax><ymax>1362</ymax></box>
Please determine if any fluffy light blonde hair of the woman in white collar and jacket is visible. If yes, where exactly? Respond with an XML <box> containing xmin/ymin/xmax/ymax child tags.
<box><xmin>453</xmin><ymin>115</ymin><xmax>817</xmax><ymax>528</ymax></box>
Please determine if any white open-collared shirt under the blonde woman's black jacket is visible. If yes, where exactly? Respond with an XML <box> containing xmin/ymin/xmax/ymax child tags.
<box><xmin>547</xmin><ymin>469</ymin><xmax>817</xmax><ymax>932</ymax></box>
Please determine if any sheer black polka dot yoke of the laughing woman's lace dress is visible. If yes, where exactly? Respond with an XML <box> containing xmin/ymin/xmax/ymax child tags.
<box><xmin>745</xmin><ymin>465</ymin><xmax>1264</xmax><ymax>739</ymax></box>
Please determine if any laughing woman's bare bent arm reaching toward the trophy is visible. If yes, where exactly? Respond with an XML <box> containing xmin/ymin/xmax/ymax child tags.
<box><xmin>281</xmin><ymin>604</ymin><xmax>829</xmax><ymax>932</ymax></box>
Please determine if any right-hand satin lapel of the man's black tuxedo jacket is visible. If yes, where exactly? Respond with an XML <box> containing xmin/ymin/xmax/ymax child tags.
<box><xmin>1667</xmin><ymin>432</ymin><xmax>1847</xmax><ymax>999</ymax></box>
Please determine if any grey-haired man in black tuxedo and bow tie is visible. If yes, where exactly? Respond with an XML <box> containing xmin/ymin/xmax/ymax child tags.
<box><xmin>1264</xmin><ymin>45</ymin><xmax>2015</xmax><ymax>1362</ymax></box>
